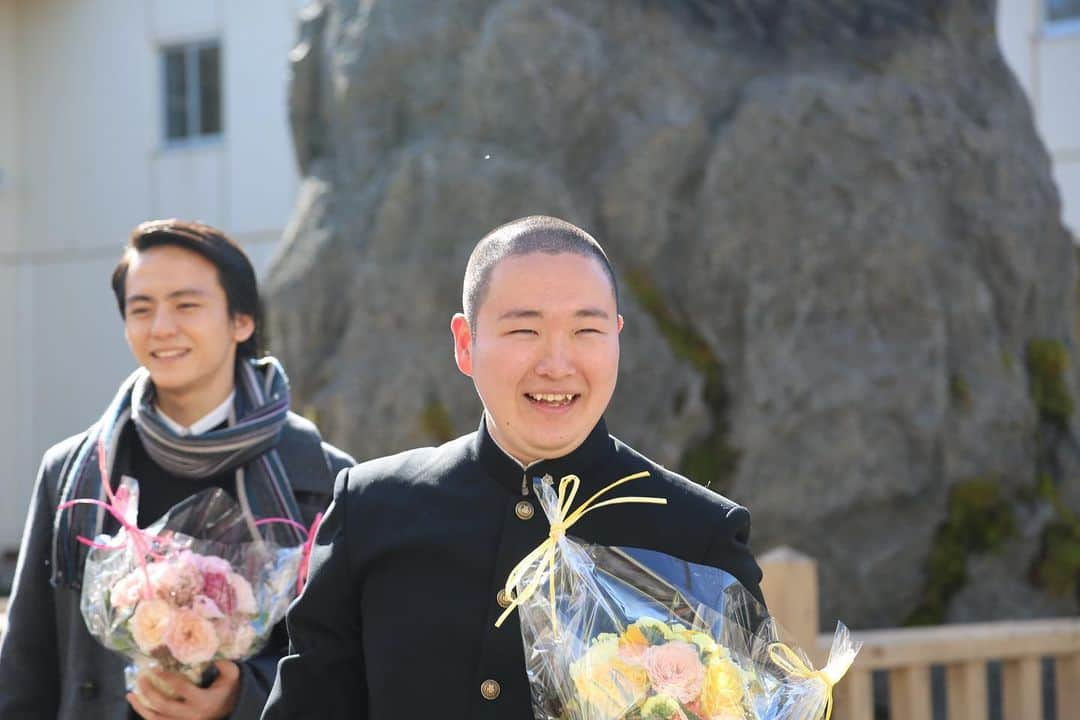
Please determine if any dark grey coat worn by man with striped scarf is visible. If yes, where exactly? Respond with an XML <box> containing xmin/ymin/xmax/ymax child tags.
<box><xmin>0</xmin><ymin>413</ymin><xmax>353</xmax><ymax>720</ymax></box>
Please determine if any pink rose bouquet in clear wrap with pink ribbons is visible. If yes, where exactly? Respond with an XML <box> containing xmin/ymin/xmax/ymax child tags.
<box><xmin>66</xmin><ymin>477</ymin><xmax>318</xmax><ymax>685</ymax></box>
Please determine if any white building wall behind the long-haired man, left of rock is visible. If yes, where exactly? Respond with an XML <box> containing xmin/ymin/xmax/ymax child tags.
<box><xmin>0</xmin><ymin>0</ymin><xmax>302</xmax><ymax>553</ymax></box>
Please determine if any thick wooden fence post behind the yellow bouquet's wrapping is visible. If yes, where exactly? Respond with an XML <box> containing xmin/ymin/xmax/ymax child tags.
<box><xmin>759</xmin><ymin>547</ymin><xmax>822</xmax><ymax>667</ymax></box>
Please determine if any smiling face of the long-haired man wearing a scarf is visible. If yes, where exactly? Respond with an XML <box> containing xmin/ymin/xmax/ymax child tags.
<box><xmin>124</xmin><ymin>245</ymin><xmax>255</xmax><ymax>424</ymax></box>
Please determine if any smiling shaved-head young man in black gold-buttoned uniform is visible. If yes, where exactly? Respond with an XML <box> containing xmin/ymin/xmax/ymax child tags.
<box><xmin>264</xmin><ymin>217</ymin><xmax>761</xmax><ymax>720</ymax></box>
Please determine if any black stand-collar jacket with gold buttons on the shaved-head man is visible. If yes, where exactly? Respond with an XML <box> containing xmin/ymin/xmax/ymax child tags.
<box><xmin>264</xmin><ymin>421</ymin><xmax>761</xmax><ymax>720</ymax></box>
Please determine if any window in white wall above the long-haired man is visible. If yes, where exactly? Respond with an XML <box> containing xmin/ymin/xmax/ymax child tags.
<box><xmin>161</xmin><ymin>40</ymin><xmax>221</xmax><ymax>142</ymax></box>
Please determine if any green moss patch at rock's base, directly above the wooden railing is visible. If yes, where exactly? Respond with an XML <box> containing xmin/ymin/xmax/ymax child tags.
<box><xmin>904</xmin><ymin>477</ymin><xmax>1016</xmax><ymax>625</ymax></box>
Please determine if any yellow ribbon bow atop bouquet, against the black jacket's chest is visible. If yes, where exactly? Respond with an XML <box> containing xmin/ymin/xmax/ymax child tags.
<box><xmin>495</xmin><ymin>471</ymin><xmax>667</xmax><ymax>627</ymax></box>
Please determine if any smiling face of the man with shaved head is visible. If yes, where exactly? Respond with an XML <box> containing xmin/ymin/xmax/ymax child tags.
<box><xmin>450</xmin><ymin>253</ymin><xmax>622</xmax><ymax>463</ymax></box>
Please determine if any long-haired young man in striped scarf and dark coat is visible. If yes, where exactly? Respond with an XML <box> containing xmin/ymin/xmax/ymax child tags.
<box><xmin>0</xmin><ymin>220</ymin><xmax>352</xmax><ymax>720</ymax></box>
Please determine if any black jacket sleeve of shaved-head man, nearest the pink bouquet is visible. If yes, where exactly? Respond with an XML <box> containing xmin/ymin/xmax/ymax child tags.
<box><xmin>262</xmin><ymin>470</ymin><xmax>368</xmax><ymax>720</ymax></box>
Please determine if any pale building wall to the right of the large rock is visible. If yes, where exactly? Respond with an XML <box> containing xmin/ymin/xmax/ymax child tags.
<box><xmin>998</xmin><ymin>0</ymin><xmax>1080</xmax><ymax>237</ymax></box>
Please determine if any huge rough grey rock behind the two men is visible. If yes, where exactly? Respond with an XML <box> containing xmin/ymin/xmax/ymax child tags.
<box><xmin>268</xmin><ymin>0</ymin><xmax>1080</xmax><ymax>626</ymax></box>
